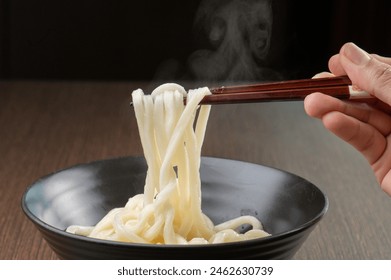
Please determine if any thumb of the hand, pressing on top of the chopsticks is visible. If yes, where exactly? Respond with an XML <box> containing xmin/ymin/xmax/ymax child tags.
<box><xmin>340</xmin><ymin>43</ymin><xmax>391</xmax><ymax>105</ymax></box>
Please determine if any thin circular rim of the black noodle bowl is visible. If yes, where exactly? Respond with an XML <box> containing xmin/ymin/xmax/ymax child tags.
<box><xmin>21</xmin><ymin>156</ymin><xmax>329</xmax><ymax>250</ymax></box>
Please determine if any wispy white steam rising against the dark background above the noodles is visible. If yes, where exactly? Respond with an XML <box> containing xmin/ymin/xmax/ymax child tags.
<box><xmin>155</xmin><ymin>0</ymin><xmax>279</xmax><ymax>81</ymax></box>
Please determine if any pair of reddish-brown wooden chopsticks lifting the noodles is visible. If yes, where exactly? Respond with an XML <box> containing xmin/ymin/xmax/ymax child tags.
<box><xmin>200</xmin><ymin>76</ymin><xmax>373</xmax><ymax>105</ymax></box>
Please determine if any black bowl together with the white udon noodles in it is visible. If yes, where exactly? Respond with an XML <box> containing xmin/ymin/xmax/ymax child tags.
<box><xmin>22</xmin><ymin>84</ymin><xmax>328</xmax><ymax>259</ymax></box>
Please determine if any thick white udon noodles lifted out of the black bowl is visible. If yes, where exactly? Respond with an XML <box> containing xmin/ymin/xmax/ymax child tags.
<box><xmin>67</xmin><ymin>84</ymin><xmax>269</xmax><ymax>244</ymax></box>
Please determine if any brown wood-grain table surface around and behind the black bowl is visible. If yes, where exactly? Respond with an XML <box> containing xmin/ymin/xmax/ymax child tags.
<box><xmin>0</xmin><ymin>81</ymin><xmax>391</xmax><ymax>259</ymax></box>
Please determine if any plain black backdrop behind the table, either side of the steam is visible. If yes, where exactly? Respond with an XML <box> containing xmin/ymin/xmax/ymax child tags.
<box><xmin>0</xmin><ymin>0</ymin><xmax>391</xmax><ymax>80</ymax></box>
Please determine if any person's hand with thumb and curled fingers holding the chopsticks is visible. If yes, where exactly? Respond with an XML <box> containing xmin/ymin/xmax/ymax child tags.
<box><xmin>304</xmin><ymin>43</ymin><xmax>391</xmax><ymax>195</ymax></box>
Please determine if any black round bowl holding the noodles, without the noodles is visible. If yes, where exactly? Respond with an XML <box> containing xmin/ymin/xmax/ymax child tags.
<box><xmin>22</xmin><ymin>157</ymin><xmax>328</xmax><ymax>260</ymax></box>
